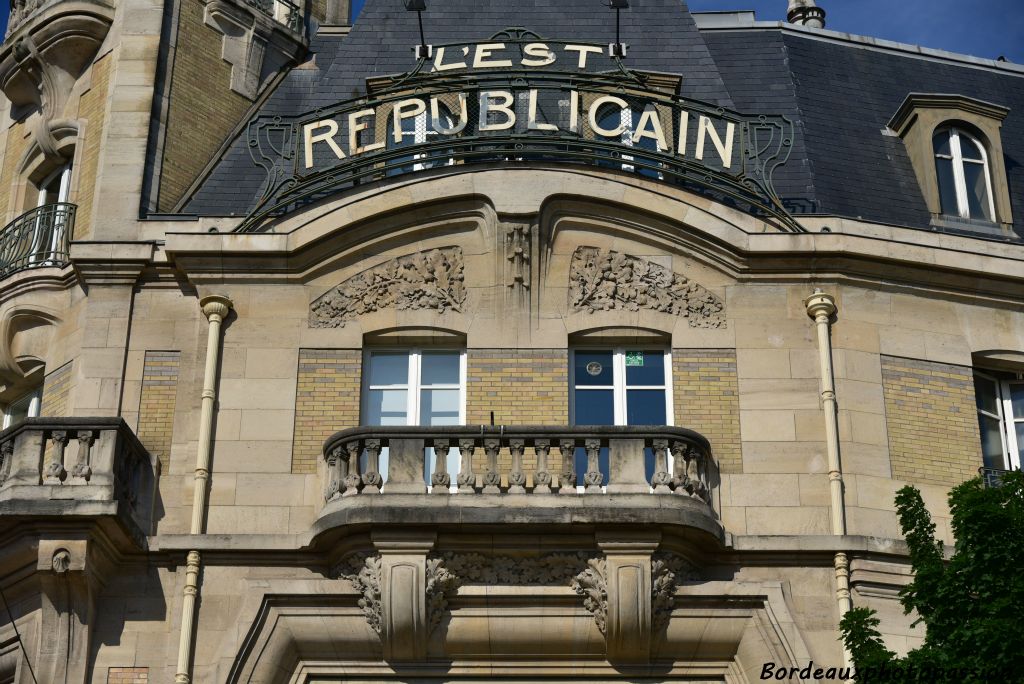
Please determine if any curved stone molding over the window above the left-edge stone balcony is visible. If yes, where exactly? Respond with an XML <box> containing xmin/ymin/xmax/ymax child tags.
<box><xmin>0</xmin><ymin>304</ymin><xmax>62</xmax><ymax>395</ymax></box>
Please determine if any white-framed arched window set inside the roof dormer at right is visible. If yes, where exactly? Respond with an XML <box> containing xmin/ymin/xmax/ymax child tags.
<box><xmin>932</xmin><ymin>126</ymin><xmax>995</xmax><ymax>222</ymax></box>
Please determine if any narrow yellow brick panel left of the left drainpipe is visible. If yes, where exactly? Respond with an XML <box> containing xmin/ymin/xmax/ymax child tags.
<box><xmin>138</xmin><ymin>351</ymin><xmax>181</xmax><ymax>468</ymax></box>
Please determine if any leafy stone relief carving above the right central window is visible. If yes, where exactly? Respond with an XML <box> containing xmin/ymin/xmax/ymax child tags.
<box><xmin>569</xmin><ymin>247</ymin><xmax>725</xmax><ymax>328</ymax></box>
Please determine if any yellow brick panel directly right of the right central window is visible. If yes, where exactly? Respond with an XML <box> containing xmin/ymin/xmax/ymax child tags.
<box><xmin>672</xmin><ymin>349</ymin><xmax>743</xmax><ymax>473</ymax></box>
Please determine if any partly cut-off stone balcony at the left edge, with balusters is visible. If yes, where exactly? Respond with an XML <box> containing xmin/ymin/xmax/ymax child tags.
<box><xmin>0</xmin><ymin>418</ymin><xmax>160</xmax><ymax>540</ymax></box>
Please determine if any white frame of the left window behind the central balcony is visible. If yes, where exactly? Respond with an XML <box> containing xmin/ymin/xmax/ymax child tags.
<box><xmin>359</xmin><ymin>347</ymin><xmax>467</xmax><ymax>493</ymax></box>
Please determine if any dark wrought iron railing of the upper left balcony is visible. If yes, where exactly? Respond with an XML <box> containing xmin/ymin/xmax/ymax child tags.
<box><xmin>0</xmin><ymin>202</ymin><xmax>77</xmax><ymax>277</ymax></box>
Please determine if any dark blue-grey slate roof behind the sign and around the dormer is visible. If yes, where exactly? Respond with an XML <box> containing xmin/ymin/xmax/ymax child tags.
<box><xmin>184</xmin><ymin>0</ymin><xmax>1024</xmax><ymax>238</ymax></box>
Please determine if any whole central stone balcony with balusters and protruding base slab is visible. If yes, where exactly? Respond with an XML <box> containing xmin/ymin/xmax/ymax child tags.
<box><xmin>314</xmin><ymin>426</ymin><xmax>724</xmax><ymax>540</ymax></box>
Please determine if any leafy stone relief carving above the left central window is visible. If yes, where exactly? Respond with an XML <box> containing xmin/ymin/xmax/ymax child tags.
<box><xmin>309</xmin><ymin>247</ymin><xmax>466</xmax><ymax>328</ymax></box>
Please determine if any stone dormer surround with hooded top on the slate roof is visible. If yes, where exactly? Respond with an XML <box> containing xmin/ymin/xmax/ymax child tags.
<box><xmin>887</xmin><ymin>93</ymin><xmax>1016</xmax><ymax>239</ymax></box>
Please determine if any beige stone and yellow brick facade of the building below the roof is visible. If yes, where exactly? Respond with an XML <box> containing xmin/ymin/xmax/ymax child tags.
<box><xmin>0</xmin><ymin>0</ymin><xmax>1024</xmax><ymax>684</ymax></box>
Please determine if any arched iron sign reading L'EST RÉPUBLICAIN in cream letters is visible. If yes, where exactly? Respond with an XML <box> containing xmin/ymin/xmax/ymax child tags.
<box><xmin>240</xmin><ymin>29</ymin><xmax>801</xmax><ymax>231</ymax></box>
